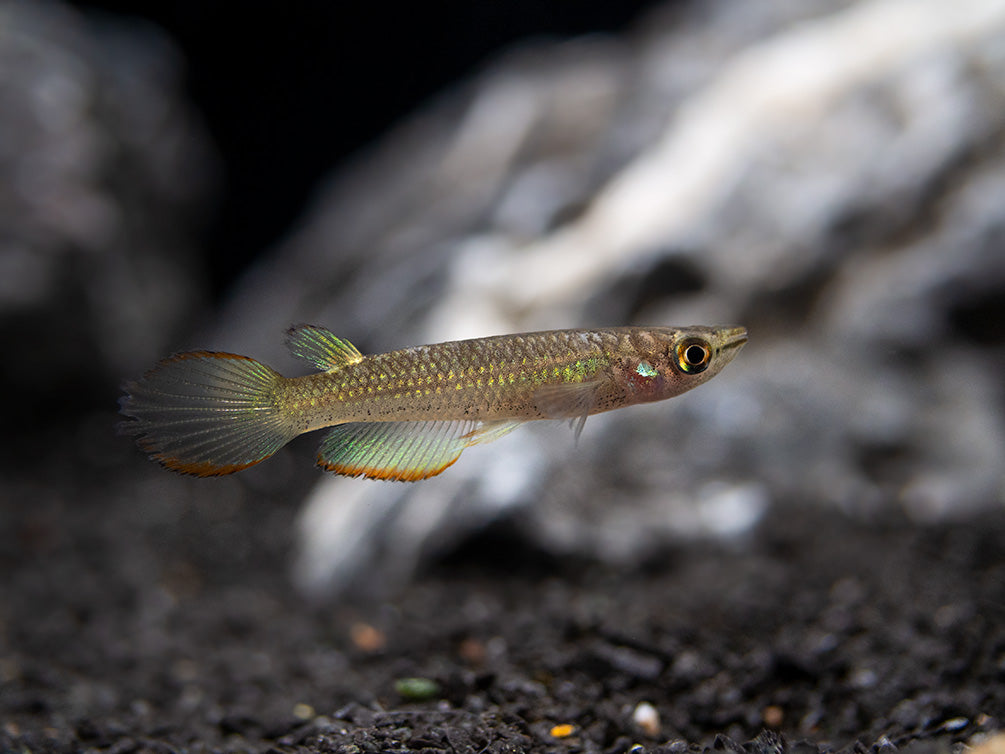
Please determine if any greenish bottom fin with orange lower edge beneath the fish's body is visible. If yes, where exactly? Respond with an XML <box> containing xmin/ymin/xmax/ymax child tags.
<box><xmin>318</xmin><ymin>421</ymin><xmax>522</xmax><ymax>482</ymax></box>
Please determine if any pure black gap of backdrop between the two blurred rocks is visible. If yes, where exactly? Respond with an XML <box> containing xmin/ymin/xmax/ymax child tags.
<box><xmin>75</xmin><ymin>0</ymin><xmax>656</xmax><ymax>298</ymax></box>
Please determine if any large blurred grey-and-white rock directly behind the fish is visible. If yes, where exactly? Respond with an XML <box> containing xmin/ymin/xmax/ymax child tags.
<box><xmin>207</xmin><ymin>0</ymin><xmax>1005</xmax><ymax>593</ymax></box>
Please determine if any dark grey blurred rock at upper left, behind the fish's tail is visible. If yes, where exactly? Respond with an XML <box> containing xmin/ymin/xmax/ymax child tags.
<box><xmin>0</xmin><ymin>2</ymin><xmax>215</xmax><ymax>426</ymax></box>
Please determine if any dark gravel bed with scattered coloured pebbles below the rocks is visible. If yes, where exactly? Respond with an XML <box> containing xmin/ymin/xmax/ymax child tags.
<box><xmin>0</xmin><ymin>460</ymin><xmax>1005</xmax><ymax>754</ymax></box>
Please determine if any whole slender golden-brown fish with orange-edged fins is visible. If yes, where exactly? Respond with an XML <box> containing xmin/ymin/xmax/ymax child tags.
<box><xmin>120</xmin><ymin>325</ymin><xmax>747</xmax><ymax>482</ymax></box>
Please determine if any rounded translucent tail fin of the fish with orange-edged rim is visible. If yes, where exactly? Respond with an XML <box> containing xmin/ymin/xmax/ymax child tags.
<box><xmin>120</xmin><ymin>351</ymin><xmax>297</xmax><ymax>477</ymax></box>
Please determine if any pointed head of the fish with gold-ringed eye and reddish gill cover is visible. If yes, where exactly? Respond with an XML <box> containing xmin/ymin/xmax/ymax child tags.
<box><xmin>617</xmin><ymin>326</ymin><xmax>747</xmax><ymax>402</ymax></box>
